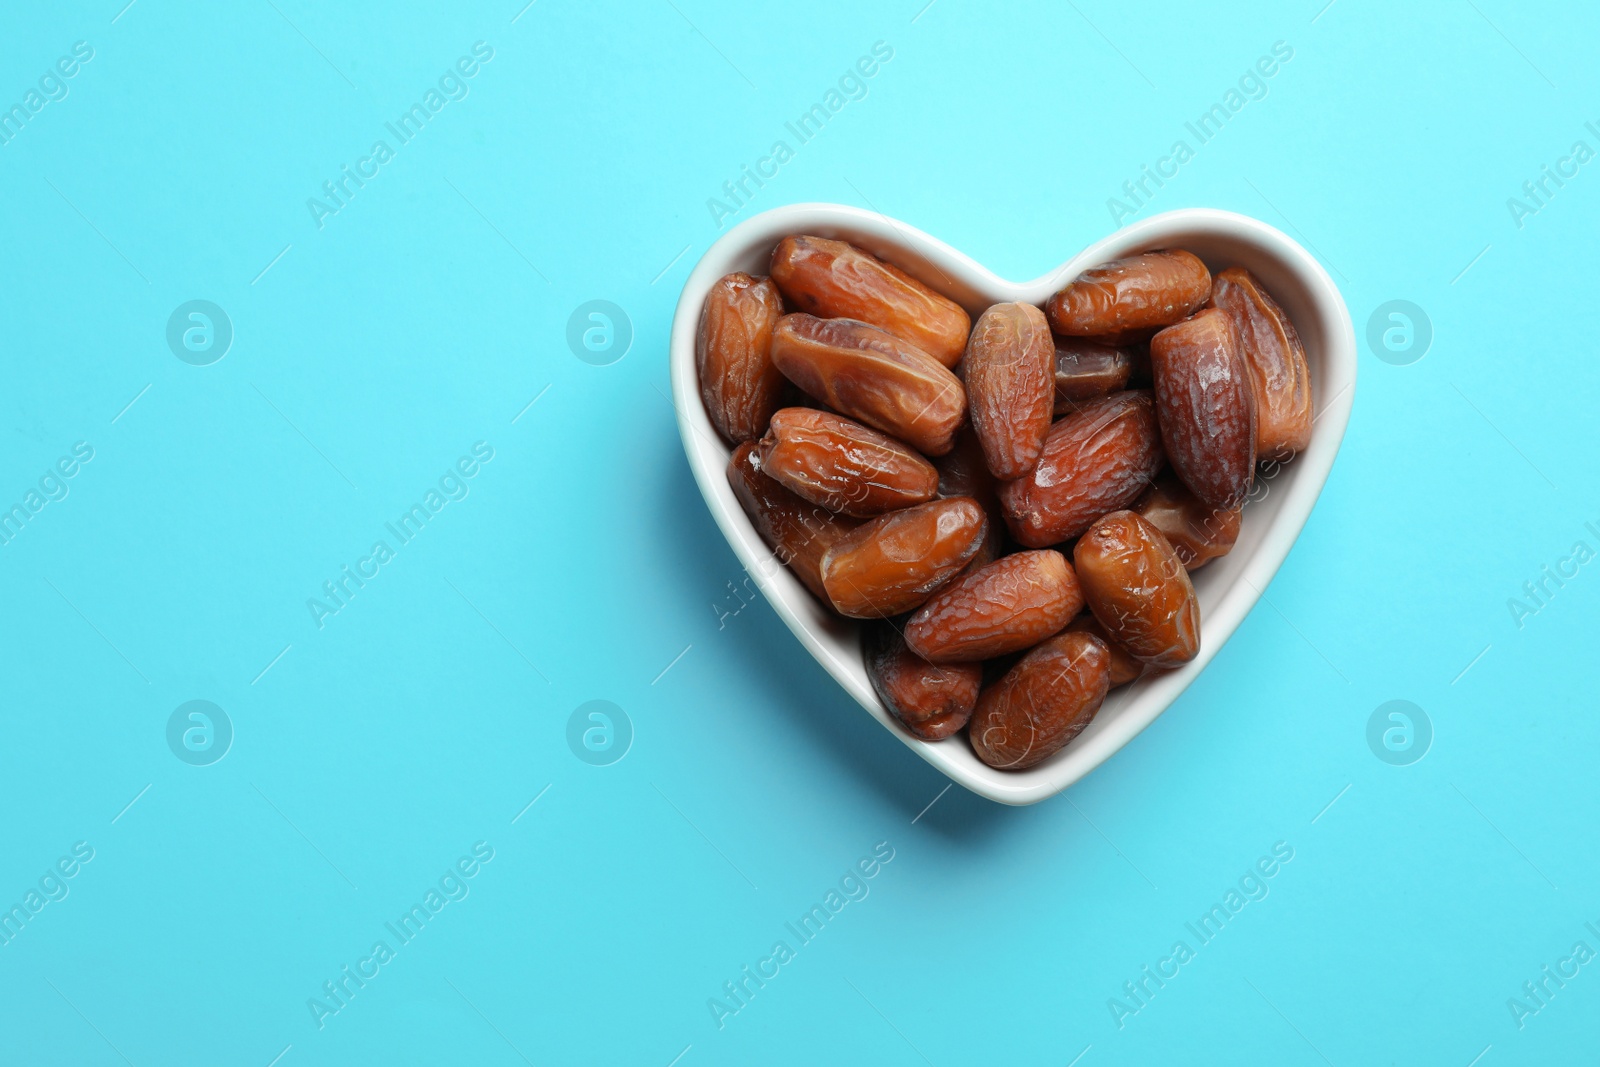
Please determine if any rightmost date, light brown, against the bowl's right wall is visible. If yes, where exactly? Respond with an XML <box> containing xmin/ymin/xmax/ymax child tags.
<box><xmin>1211</xmin><ymin>267</ymin><xmax>1314</xmax><ymax>461</ymax></box>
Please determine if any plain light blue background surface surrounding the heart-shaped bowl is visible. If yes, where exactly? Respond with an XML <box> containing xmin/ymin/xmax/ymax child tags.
<box><xmin>0</xmin><ymin>0</ymin><xmax>1600</xmax><ymax>1067</ymax></box>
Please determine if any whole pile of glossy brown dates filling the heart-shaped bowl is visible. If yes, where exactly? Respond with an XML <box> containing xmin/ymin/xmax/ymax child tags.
<box><xmin>696</xmin><ymin>237</ymin><xmax>1312</xmax><ymax>769</ymax></box>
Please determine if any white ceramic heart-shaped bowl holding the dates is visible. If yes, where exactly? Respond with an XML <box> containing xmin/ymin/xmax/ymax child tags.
<box><xmin>672</xmin><ymin>203</ymin><xmax>1355</xmax><ymax>805</ymax></box>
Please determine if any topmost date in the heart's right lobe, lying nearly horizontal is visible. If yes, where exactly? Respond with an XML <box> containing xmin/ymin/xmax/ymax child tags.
<box><xmin>1043</xmin><ymin>250</ymin><xmax>1211</xmax><ymax>341</ymax></box>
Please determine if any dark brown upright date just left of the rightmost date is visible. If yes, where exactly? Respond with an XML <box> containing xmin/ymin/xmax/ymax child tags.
<box><xmin>1150</xmin><ymin>307</ymin><xmax>1256</xmax><ymax>509</ymax></box>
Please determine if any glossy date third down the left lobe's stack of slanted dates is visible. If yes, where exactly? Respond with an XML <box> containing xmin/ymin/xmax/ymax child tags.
<box><xmin>755</xmin><ymin>408</ymin><xmax>939</xmax><ymax>517</ymax></box>
